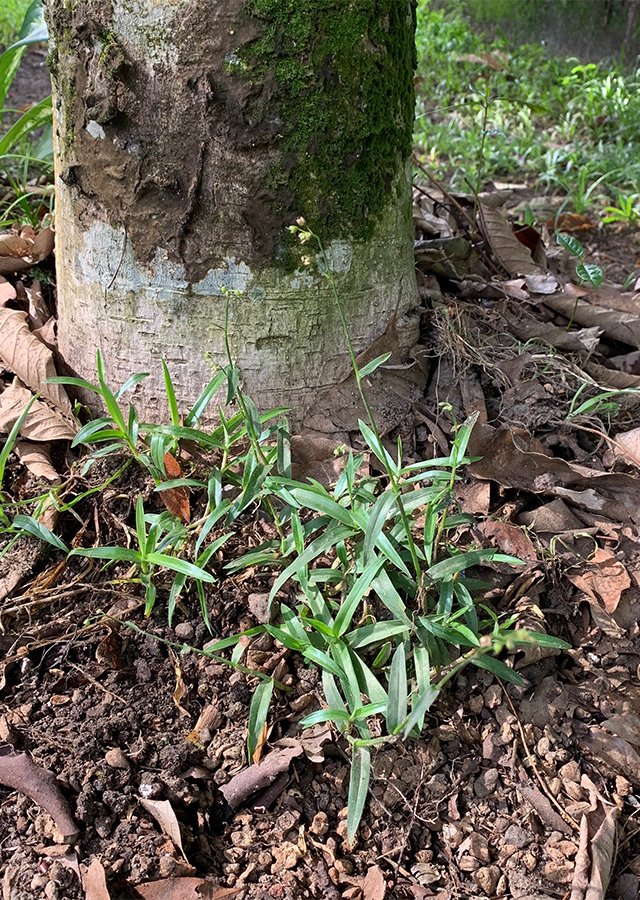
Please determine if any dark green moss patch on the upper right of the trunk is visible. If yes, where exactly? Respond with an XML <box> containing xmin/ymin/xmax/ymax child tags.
<box><xmin>242</xmin><ymin>0</ymin><xmax>415</xmax><ymax>240</ymax></box>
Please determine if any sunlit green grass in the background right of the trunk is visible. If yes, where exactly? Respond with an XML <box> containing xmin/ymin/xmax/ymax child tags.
<box><xmin>415</xmin><ymin>0</ymin><xmax>640</xmax><ymax>212</ymax></box>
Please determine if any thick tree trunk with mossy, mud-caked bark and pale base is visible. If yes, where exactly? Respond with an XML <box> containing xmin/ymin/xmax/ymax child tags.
<box><xmin>48</xmin><ymin>0</ymin><xmax>417</xmax><ymax>420</ymax></box>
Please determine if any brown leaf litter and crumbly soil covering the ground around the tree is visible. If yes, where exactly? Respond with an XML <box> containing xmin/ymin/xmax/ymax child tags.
<box><xmin>0</xmin><ymin>182</ymin><xmax>640</xmax><ymax>900</ymax></box>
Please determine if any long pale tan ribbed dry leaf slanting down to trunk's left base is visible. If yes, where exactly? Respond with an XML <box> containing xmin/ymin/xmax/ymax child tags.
<box><xmin>0</xmin><ymin>307</ymin><xmax>71</xmax><ymax>413</ymax></box>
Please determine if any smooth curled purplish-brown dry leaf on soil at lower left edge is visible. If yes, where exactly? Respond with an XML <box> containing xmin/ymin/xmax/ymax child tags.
<box><xmin>0</xmin><ymin>746</ymin><xmax>80</xmax><ymax>844</ymax></box>
